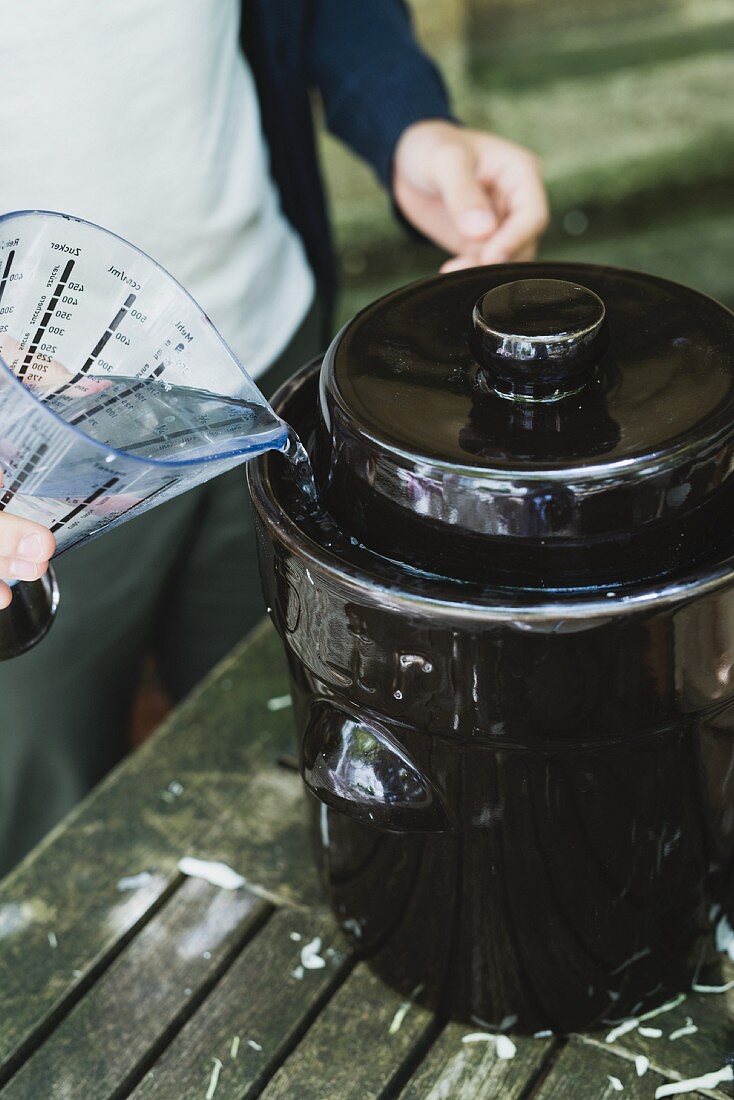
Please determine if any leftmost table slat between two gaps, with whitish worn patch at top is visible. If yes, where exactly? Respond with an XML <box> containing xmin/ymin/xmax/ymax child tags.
<box><xmin>1</xmin><ymin>879</ymin><xmax>264</xmax><ymax>1100</ymax></box>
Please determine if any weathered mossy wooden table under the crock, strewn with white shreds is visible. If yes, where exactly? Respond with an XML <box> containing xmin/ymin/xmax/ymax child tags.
<box><xmin>0</xmin><ymin>625</ymin><xmax>734</xmax><ymax>1100</ymax></box>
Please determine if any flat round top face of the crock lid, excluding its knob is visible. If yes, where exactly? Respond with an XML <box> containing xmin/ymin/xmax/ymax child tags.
<box><xmin>325</xmin><ymin>264</ymin><xmax>734</xmax><ymax>472</ymax></box>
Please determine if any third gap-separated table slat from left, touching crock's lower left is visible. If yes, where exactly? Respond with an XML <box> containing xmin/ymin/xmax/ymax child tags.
<box><xmin>262</xmin><ymin>964</ymin><xmax>436</xmax><ymax>1100</ymax></box>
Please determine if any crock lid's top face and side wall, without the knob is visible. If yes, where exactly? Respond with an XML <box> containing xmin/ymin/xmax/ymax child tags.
<box><xmin>316</xmin><ymin>264</ymin><xmax>734</xmax><ymax>563</ymax></box>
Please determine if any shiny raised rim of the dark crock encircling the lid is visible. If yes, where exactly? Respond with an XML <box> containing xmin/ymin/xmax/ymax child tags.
<box><xmin>248</xmin><ymin>360</ymin><xmax>734</xmax><ymax>616</ymax></box>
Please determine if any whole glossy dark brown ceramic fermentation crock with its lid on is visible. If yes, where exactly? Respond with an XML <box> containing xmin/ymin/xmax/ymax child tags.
<box><xmin>249</xmin><ymin>264</ymin><xmax>734</xmax><ymax>1031</ymax></box>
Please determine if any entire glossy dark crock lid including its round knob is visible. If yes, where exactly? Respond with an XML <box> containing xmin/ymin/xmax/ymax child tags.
<box><xmin>319</xmin><ymin>264</ymin><xmax>734</xmax><ymax>589</ymax></box>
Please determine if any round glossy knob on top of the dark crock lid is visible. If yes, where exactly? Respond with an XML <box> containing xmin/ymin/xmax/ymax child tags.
<box><xmin>473</xmin><ymin>278</ymin><xmax>609</xmax><ymax>402</ymax></box>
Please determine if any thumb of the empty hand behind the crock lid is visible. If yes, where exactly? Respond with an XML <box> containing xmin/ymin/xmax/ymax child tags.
<box><xmin>432</xmin><ymin>142</ymin><xmax>497</xmax><ymax>241</ymax></box>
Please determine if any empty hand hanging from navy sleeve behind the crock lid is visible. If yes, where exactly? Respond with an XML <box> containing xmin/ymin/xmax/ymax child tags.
<box><xmin>393</xmin><ymin>119</ymin><xmax>548</xmax><ymax>272</ymax></box>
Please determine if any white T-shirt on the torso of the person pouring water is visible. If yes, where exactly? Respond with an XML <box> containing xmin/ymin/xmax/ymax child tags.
<box><xmin>0</xmin><ymin>0</ymin><xmax>314</xmax><ymax>374</ymax></box>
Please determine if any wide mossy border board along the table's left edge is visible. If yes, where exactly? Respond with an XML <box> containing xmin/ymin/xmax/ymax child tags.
<box><xmin>0</xmin><ymin>624</ymin><xmax>320</xmax><ymax>1082</ymax></box>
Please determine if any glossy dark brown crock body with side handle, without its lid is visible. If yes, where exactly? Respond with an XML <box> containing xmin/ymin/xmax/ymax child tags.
<box><xmin>250</xmin><ymin>360</ymin><xmax>734</xmax><ymax>1031</ymax></box>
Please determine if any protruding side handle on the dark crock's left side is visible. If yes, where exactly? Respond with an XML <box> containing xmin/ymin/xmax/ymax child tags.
<box><xmin>300</xmin><ymin>700</ymin><xmax>450</xmax><ymax>833</ymax></box>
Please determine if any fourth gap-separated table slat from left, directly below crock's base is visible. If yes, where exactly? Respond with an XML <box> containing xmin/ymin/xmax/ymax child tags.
<box><xmin>399</xmin><ymin>1023</ymin><xmax>554</xmax><ymax>1100</ymax></box>
